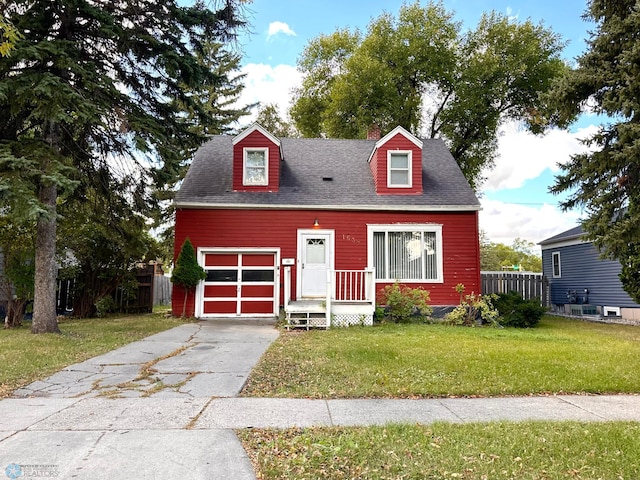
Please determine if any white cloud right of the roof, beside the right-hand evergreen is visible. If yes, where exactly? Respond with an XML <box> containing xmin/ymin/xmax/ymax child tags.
<box><xmin>483</xmin><ymin>125</ymin><xmax>597</xmax><ymax>191</ymax></box>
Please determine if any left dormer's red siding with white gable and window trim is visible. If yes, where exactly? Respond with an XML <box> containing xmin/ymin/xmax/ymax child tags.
<box><xmin>233</xmin><ymin>124</ymin><xmax>282</xmax><ymax>192</ymax></box>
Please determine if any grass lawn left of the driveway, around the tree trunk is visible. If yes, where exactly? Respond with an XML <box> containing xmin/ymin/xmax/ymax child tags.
<box><xmin>0</xmin><ymin>314</ymin><xmax>190</xmax><ymax>398</ymax></box>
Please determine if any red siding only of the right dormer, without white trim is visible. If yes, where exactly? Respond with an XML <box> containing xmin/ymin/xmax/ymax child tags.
<box><xmin>370</xmin><ymin>133</ymin><xmax>422</xmax><ymax>195</ymax></box>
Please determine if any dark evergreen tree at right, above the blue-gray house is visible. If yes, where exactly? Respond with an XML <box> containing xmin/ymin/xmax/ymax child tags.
<box><xmin>551</xmin><ymin>0</ymin><xmax>640</xmax><ymax>302</ymax></box>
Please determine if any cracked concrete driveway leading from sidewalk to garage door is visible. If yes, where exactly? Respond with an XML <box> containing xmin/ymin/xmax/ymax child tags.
<box><xmin>13</xmin><ymin>322</ymin><xmax>278</xmax><ymax>398</ymax></box>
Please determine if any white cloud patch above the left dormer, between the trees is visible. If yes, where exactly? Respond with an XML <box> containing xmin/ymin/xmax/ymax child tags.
<box><xmin>238</xmin><ymin>63</ymin><xmax>302</xmax><ymax>123</ymax></box>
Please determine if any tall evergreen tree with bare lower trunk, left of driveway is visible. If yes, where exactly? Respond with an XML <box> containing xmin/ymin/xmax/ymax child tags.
<box><xmin>0</xmin><ymin>0</ymin><xmax>242</xmax><ymax>333</ymax></box>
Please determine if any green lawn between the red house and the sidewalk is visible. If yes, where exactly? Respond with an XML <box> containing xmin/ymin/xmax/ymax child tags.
<box><xmin>243</xmin><ymin>316</ymin><xmax>640</xmax><ymax>398</ymax></box>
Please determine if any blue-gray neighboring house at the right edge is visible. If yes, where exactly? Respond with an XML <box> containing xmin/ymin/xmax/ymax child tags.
<box><xmin>540</xmin><ymin>226</ymin><xmax>640</xmax><ymax>324</ymax></box>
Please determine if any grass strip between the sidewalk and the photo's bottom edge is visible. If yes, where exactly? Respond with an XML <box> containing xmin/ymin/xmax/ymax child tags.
<box><xmin>238</xmin><ymin>422</ymin><xmax>640</xmax><ymax>480</ymax></box>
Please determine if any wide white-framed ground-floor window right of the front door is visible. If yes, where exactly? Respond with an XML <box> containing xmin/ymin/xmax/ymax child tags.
<box><xmin>367</xmin><ymin>224</ymin><xmax>444</xmax><ymax>283</ymax></box>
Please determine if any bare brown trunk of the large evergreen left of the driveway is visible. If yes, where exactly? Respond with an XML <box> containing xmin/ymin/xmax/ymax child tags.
<box><xmin>31</xmin><ymin>184</ymin><xmax>60</xmax><ymax>333</ymax></box>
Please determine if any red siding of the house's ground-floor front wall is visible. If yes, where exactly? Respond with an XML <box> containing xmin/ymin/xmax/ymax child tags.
<box><xmin>173</xmin><ymin>209</ymin><xmax>480</xmax><ymax>314</ymax></box>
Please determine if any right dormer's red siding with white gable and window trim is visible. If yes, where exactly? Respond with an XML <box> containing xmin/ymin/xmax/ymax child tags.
<box><xmin>369</xmin><ymin>127</ymin><xmax>422</xmax><ymax>195</ymax></box>
